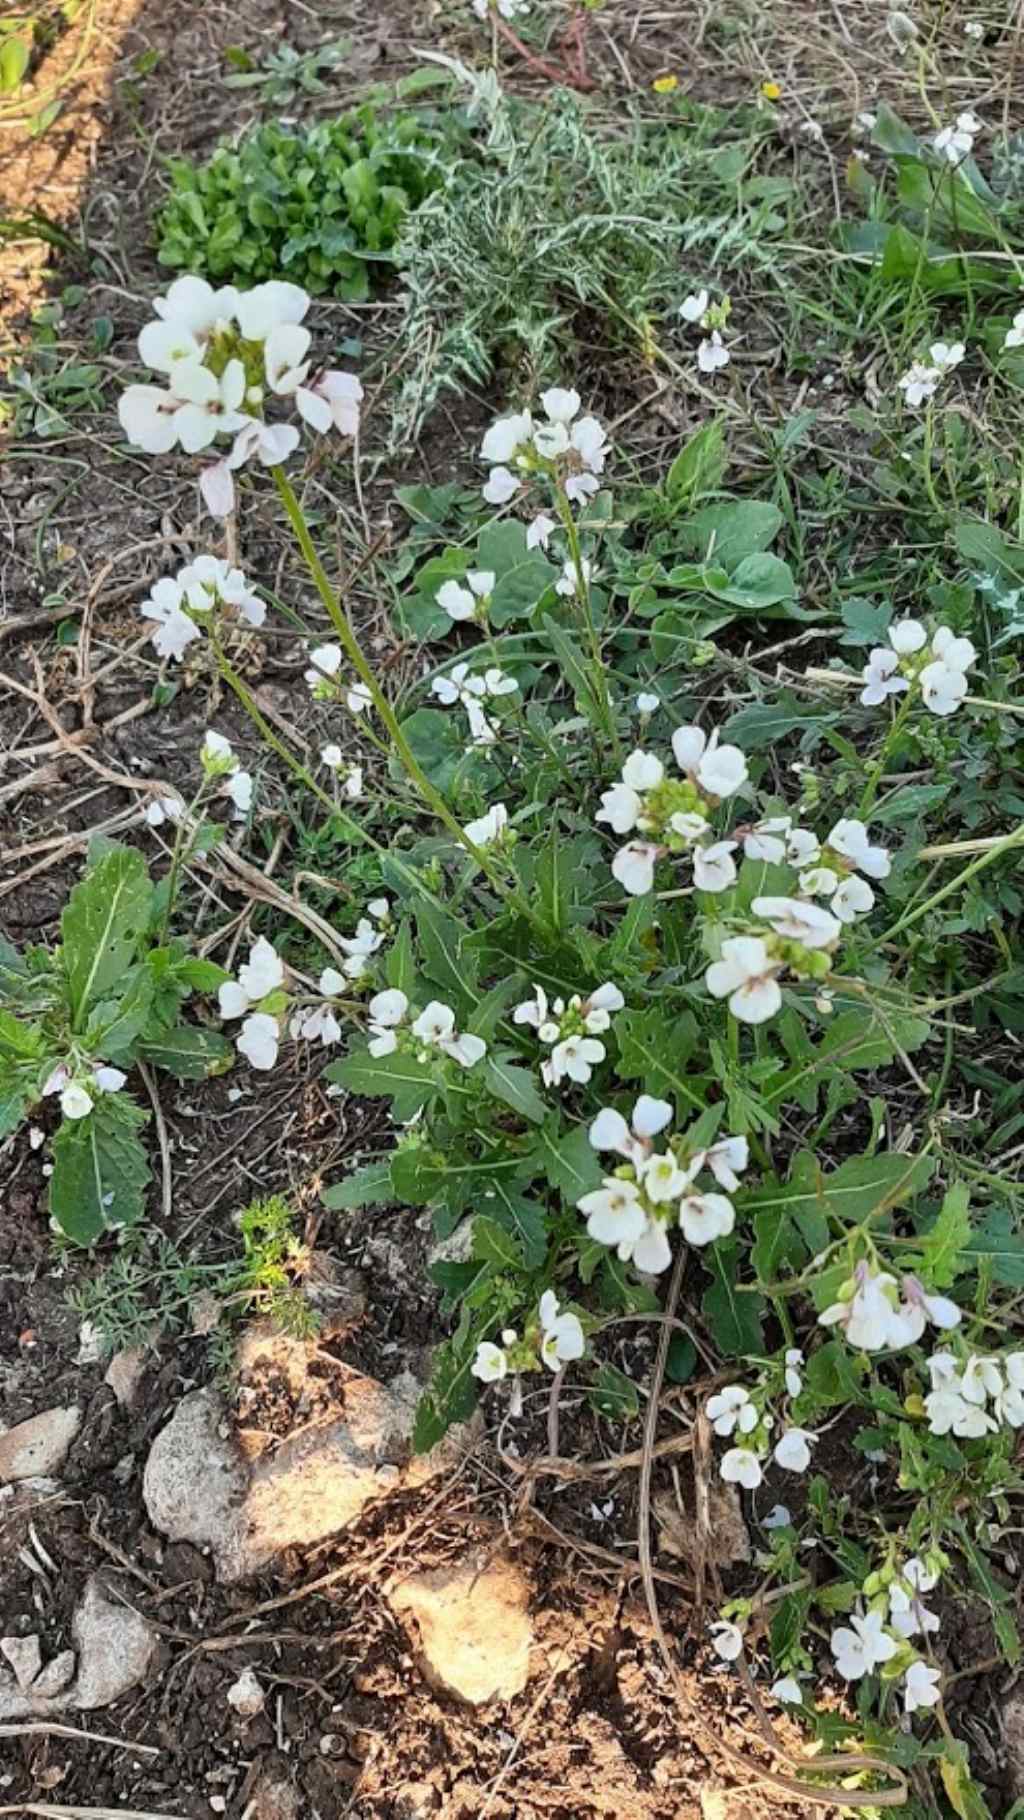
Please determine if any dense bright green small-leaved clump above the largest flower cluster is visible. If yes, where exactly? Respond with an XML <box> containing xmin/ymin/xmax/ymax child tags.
<box><xmin>158</xmin><ymin>106</ymin><xmax>452</xmax><ymax>300</ymax></box>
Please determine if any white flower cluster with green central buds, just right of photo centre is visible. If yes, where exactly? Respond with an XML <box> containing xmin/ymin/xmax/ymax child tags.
<box><xmin>595</xmin><ymin>726</ymin><xmax>748</xmax><ymax>897</ymax></box>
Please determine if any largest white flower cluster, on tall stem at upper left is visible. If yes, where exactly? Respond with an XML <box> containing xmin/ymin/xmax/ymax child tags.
<box><xmin>118</xmin><ymin>277</ymin><xmax>362</xmax><ymax>517</ymax></box>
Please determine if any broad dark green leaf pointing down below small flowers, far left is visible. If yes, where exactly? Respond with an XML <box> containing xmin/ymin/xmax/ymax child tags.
<box><xmin>49</xmin><ymin>1094</ymin><xmax>149</xmax><ymax>1245</ymax></box>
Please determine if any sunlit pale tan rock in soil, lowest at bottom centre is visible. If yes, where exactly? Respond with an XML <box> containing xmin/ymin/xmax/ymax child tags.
<box><xmin>389</xmin><ymin>1554</ymin><xmax>533</xmax><ymax>1705</ymax></box>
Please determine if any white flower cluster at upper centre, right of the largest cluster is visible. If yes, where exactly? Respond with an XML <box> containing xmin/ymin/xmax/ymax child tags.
<box><xmin>480</xmin><ymin>386</ymin><xmax>607</xmax><ymax>509</ymax></box>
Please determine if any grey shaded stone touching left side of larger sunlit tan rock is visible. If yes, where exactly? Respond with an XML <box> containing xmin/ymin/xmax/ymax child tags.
<box><xmin>142</xmin><ymin>1390</ymin><xmax>247</xmax><ymax>1552</ymax></box>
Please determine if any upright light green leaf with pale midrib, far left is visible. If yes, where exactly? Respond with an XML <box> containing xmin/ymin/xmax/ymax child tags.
<box><xmin>60</xmin><ymin>846</ymin><xmax>153</xmax><ymax>1028</ymax></box>
